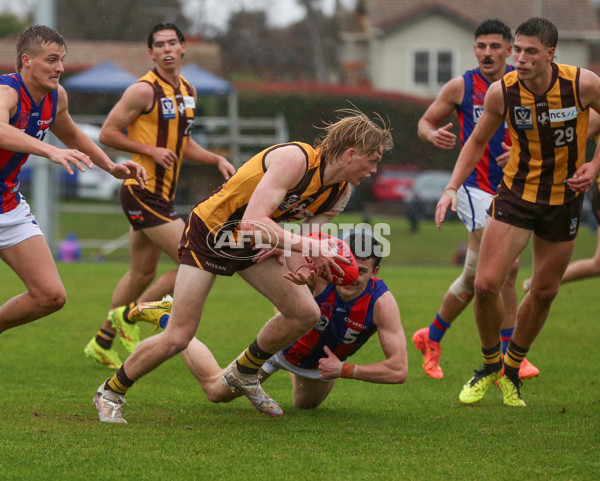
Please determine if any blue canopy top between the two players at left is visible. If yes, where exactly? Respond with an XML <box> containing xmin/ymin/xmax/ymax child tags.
<box><xmin>61</xmin><ymin>62</ymin><xmax>137</xmax><ymax>93</ymax></box>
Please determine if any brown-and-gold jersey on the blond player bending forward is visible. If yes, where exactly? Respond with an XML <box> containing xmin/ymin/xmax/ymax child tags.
<box><xmin>189</xmin><ymin>142</ymin><xmax>349</xmax><ymax>247</ymax></box>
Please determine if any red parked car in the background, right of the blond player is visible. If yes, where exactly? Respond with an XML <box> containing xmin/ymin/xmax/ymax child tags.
<box><xmin>371</xmin><ymin>164</ymin><xmax>420</xmax><ymax>202</ymax></box>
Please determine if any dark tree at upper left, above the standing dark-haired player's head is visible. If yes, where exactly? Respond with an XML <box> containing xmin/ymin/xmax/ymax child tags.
<box><xmin>56</xmin><ymin>0</ymin><xmax>189</xmax><ymax>40</ymax></box>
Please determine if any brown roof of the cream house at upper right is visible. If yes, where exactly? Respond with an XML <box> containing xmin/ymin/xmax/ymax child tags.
<box><xmin>359</xmin><ymin>0</ymin><xmax>600</xmax><ymax>41</ymax></box>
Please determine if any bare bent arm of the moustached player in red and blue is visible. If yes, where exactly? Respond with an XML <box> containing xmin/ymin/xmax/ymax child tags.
<box><xmin>417</xmin><ymin>77</ymin><xmax>465</xmax><ymax>150</ymax></box>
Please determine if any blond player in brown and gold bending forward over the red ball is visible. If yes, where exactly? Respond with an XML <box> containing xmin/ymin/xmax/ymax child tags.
<box><xmin>94</xmin><ymin>110</ymin><xmax>393</xmax><ymax>422</ymax></box>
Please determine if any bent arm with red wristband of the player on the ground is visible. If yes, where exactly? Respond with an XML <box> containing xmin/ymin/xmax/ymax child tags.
<box><xmin>319</xmin><ymin>291</ymin><xmax>408</xmax><ymax>384</ymax></box>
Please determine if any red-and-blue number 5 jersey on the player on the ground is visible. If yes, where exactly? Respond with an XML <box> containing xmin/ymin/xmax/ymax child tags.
<box><xmin>282</xmin><ymin>279</ymin><xmax>388</xmax><ymax>369</ymax></box>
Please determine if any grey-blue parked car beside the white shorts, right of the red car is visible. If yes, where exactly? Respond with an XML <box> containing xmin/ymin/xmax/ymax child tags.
<box><xmin>406</xmin><ymin>170</ymin><xmax>456</xmax><ymax>219</ymax></box>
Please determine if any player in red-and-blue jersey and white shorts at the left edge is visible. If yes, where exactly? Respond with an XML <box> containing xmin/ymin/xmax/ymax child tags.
<box><xmin>0</xmin><ymin>25</ymin><xmax>146</xmax><ymax>332</ymax></box>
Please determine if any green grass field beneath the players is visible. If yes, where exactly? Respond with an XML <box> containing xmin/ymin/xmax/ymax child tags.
<box><xmin>0</xmin><ymin>211</ymin><xmax>600</xmax><ymax>481</ymax></box>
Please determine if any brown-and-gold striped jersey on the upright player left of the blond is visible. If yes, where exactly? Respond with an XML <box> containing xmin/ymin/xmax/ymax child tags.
<box><xmin>125</xmin><ymin>69</ymin><xmax>196</xmax><ymax>202</ymax></box>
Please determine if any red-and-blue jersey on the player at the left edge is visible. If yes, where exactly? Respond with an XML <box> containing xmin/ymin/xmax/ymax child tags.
<box><xmin>0</xmin><ymin>73</ymin><xmax>58</xmax><ymax>213</ymax></box>
